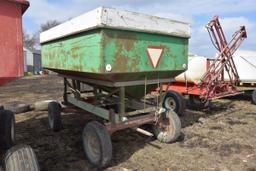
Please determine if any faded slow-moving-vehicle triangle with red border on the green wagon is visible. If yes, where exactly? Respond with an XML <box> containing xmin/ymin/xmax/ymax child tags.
<box><xmin>146</xmin><ymin>46</ymin><xmax>164</xmax><ymax>68</ymax></box>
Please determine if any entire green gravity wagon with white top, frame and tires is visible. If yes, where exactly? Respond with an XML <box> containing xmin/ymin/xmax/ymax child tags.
<box><xmin>40</xmin><ymin>7</ymin><xmax>190</xmax><ymax>167</ymax></box>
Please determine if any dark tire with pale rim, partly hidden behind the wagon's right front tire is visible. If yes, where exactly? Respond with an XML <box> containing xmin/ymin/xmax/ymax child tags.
<box><xmin>163</xmin><ymin>90</ymin><xmax>186</xmax><ymax>116</ymax></box>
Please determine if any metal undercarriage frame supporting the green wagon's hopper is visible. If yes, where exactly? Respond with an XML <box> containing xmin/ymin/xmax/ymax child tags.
<box><xmin>59</xmin><ymin>75</ymin><xmax>170</xmax><ymax>134</ymax></box>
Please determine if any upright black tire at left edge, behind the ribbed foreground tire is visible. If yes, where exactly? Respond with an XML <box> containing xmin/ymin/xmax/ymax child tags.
<box><xmin>0</xmin><ymin>110</ymin><xmax>15</xmax><ymax>150</ymax></box>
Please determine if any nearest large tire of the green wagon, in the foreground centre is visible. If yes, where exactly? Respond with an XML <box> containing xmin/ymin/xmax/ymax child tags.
<box><xmin>82</xmin><ymin>121</ymin><xmax>112</xmax><ymax>168</ymax></box>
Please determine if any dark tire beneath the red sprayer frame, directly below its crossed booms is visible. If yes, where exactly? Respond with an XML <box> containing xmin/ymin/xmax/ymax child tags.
<box><xmin>189</xmin><ymin>95</ymin><xmax>210</xmax><ymax>109</ymax></box>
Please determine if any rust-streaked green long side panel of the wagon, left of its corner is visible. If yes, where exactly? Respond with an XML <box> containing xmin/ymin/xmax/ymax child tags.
<box><xmin>41</xmin><ymin>30</ymin><xmax>104</xmax><ymax>73</ymax></box>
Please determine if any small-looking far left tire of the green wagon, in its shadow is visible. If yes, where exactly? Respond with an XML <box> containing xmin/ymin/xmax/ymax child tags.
<box><xmin>48</xmin><ymin>102</ymin><xmax>62</xmax><ymax>132</ymax></box>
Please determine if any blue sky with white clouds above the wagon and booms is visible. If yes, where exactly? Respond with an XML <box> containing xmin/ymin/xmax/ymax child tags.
<box><xmin>23</xmin><ymin>0</ymin><xmax>256</xmax><ymax>57</ymax></box>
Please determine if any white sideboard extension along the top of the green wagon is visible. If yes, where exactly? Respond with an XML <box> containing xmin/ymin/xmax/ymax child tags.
<box><xmin>40</xmin><ymin>7</ymin><xmax>190</xmax><ymax>43</ymax></box>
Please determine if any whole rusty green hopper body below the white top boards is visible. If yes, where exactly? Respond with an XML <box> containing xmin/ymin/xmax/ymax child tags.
<box><xmin>42</xmin><ymin>28</ymin><xmax>188</xmax><ymax>81</ymax></box>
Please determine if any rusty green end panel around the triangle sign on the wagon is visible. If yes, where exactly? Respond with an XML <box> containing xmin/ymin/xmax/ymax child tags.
<box><xmin>103</xmin><ymin>29</ymin><xmax>188</xmax><ymax>73</ymax></box>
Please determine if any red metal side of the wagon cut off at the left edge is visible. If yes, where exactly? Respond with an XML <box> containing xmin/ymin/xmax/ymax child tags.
<box><xmin>0</xmin><ymin>1</ymin><xmax>27</xmax><ymax>85</ymax></box>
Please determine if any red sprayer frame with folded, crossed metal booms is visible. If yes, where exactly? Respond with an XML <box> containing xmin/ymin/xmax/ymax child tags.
<box><xmin>162</xmin><ymin>16</ymin><xmax>247</xmax><ymax>110</ymax></box>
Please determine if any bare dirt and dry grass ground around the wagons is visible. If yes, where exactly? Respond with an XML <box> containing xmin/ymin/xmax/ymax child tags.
<box><xmin>0</xmin><ymin>75</ymin><xmax>256</xmax><ymax>171</ymax></box>
